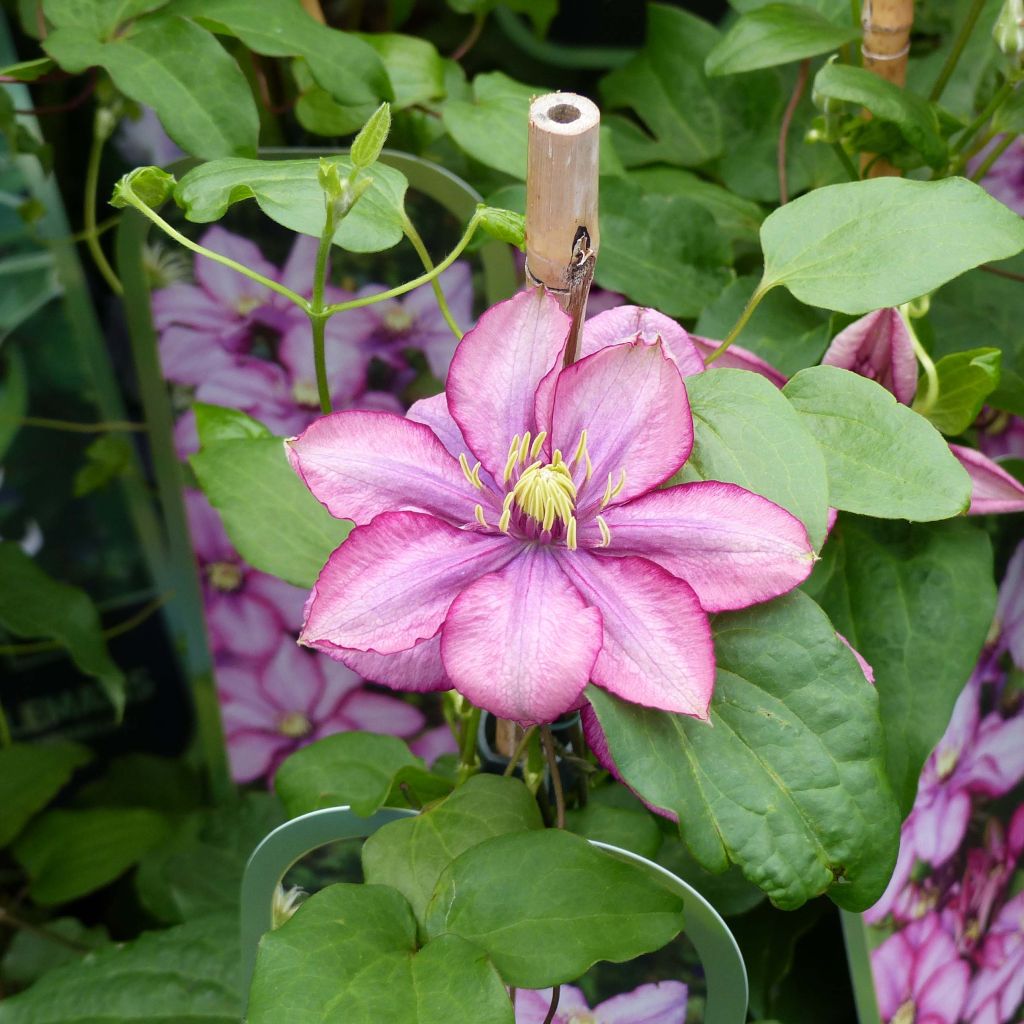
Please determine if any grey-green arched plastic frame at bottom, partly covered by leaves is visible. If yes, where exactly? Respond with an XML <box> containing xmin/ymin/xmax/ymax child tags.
<box><xmin>241</xmin><ymin>807</ymin><xmax>748</xmax><ymax>1024</ymax></box>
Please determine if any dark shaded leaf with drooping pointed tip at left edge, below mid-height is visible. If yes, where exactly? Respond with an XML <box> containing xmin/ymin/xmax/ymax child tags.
<box><xmin>0</xmin><ymin>542</ymin><xmax>125</xmax><ymax>721</ymax></box>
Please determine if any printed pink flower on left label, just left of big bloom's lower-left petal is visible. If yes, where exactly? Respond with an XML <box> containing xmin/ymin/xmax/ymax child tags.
<box><xmin>184</xmin><ymin>490</ymin><xmax>304</xmax><ymax>657</ymax></box>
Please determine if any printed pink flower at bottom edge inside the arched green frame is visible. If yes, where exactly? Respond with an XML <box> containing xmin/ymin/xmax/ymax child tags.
<box><xmin>515</xmin><ymin>981</ymin><xmax>688</xmax><ymax>1024</ymax></box>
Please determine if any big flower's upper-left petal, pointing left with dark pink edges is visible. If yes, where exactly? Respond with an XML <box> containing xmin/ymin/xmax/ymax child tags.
<box><xmin>286</xmin><ymin>411</ymin><xmax>481</xmax><ymax>524</ymax></box>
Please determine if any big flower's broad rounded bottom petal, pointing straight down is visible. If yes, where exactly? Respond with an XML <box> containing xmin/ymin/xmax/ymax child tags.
<box><xmin>441</xmin><ymin>547</ymin><xmax>601</xmax><ymax>725</ymax></box>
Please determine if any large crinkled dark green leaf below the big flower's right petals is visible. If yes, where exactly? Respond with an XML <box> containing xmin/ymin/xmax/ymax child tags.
<box><xmin>588</xmin><ymin>593</ymin><xmax>899</xmax><ymax>910</ymax></box>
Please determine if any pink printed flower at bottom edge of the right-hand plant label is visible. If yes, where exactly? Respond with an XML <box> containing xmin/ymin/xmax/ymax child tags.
<box><xmin>871</xmin><ymin>913</ymin><xmax>971</xmax><ymax>1024</ymax></box>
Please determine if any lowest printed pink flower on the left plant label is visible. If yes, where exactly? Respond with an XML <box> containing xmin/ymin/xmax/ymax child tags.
<box><xmin>216</xmin><ymin>634</ymin><xmax>423</xmax><ymax>782</ymax></box>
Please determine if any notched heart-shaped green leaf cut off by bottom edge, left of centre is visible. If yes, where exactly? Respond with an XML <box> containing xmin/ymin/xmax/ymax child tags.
<box><xmin>249</xmin><ymin>884</ymin><xmax>514</xmax><ymax>1024</ymax></box>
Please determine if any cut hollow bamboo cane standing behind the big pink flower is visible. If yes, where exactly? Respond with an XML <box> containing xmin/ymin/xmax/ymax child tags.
<box><xmin>495</xmin><ymin>92</ymin><xmax>601</xmax><ymax>757</ymax></box>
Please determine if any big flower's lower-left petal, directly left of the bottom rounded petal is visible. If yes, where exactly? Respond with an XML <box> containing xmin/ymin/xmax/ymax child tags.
<box><xmin>299</xmin><ymin>512</ymin><xmax>519</xmax><ymax>654</ymax></box>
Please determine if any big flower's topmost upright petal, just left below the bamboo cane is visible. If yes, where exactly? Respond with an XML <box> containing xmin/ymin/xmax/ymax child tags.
<box><xmin>447</xmin><ymin>289</ymin><xmax>578</xmax><ymax>477</ymax></box>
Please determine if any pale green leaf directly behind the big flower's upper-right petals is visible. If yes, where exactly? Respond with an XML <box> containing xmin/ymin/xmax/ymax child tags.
<box><xmin>684</xmin><ymin>370</ymin><xmax>828</xmax><ymax>550</ymax></box>
